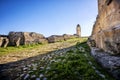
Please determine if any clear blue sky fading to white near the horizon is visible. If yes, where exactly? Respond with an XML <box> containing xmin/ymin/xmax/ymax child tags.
<box><xmin>0</xmin><ymin>0</ymin><xmax>97</xmax><ymax>37</ymax></box>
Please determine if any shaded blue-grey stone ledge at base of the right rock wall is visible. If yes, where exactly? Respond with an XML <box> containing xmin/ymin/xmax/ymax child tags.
<box><xmin>91</xmin><ymin>47</ymin><xmax>120</xmax><ymax>80</ymax></box>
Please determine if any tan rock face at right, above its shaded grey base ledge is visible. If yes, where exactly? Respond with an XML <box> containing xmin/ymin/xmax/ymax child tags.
<box><xmin>90</xmin><ymin>0</ymin><xmax>120</xmax><ymax>54</ymax></box>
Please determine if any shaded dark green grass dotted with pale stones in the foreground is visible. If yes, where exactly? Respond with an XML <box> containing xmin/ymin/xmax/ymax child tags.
<box><xmin>20</xmin><ymin>42</ymin><xmax>115</xmax><ymax>80</ymax></box>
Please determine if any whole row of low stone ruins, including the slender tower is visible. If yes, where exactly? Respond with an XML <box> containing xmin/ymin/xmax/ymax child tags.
<box><xmin>0</xmin><ymin>24</ymin><xmax>81</xmax><ymax>47</ymax></box>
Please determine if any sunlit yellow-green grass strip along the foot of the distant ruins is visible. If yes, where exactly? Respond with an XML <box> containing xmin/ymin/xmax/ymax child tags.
<box><xmin>0</xmin><ymin>38</ymin><xmax>87</xmax><ymax>56</ymax></box>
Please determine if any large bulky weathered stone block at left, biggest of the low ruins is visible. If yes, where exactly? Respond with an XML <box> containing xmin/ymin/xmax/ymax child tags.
<box><xmin>8</xmin><ymin>32</ymin><xmax>47</xmax><ymax>46</ymax></box>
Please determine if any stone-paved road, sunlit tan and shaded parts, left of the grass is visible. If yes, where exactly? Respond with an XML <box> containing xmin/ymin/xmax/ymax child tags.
<box><xmin>0</xmin><ymin>42</ymin><xmax>76</xmax><ymax>80</ymax></box>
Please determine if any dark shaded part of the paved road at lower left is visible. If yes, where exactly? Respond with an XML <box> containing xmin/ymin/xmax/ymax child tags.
<box><xmin>0</xmin><ymin>46</ymin><xmax>74</xmax><ymax>80</ymax></box>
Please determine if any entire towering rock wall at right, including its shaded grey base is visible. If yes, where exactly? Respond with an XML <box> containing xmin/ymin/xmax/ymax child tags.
<box><xmin>88</xmin><ymin>0</ymin><xmax>120</xmax><ymax>80</ymax></box>
